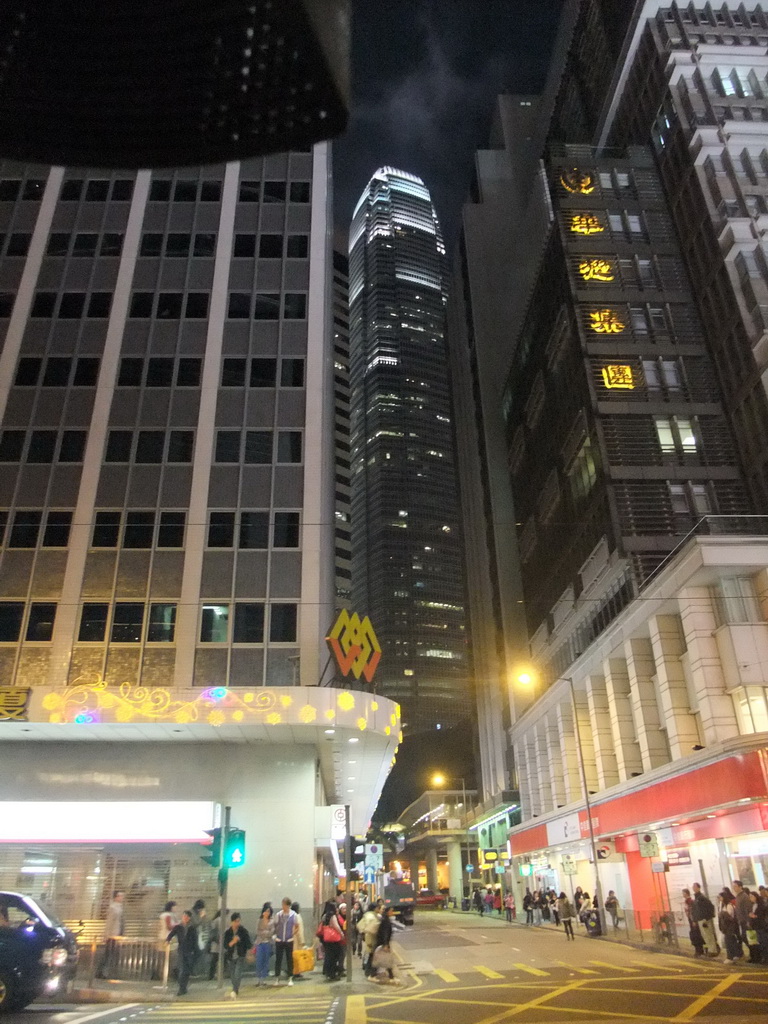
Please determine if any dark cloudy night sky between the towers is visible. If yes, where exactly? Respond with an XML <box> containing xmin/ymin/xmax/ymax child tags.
<box><xmin>334</xmin><ymin>0</ymin><xmax>560</xmax><ymax>252</ymax></box>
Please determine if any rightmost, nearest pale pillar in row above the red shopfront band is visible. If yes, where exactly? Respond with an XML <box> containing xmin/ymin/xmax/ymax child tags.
<box><xmin>678</xmin><ymin>587</ymin><xmax>738</xmax><ymax>744</ymax></box>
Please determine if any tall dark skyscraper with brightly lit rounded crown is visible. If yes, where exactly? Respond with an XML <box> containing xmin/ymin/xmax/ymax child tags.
<box><xmin>349</xmin><ymin>167</ymin><xmax>471</xmax><ymax>731</ymax></box>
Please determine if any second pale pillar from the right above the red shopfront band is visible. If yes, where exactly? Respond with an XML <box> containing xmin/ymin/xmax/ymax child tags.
<box><xmin>648</xmin><ymin>615</ymin><xmax>699</xmax><ymax>761</ymax></box>
